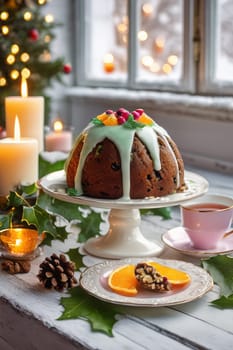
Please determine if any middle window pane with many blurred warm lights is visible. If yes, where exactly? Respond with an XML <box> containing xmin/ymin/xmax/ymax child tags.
<box><xmin>138</xmin><ymin>0</ymin><xmax>183</xmax><ymax>81</ymax></box>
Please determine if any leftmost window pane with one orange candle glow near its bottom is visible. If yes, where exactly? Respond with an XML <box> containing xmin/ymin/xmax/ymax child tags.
<box><xmin>86</xmin><ymin>0</ymin><xmax>128</xmax><ymax>80</ymax></box>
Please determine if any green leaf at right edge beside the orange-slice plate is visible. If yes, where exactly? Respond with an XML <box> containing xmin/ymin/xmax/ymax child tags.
<box><xmin>202</xmin><ymin>255</ymin><xmax>233</xmax><ymax>309</ymax></box>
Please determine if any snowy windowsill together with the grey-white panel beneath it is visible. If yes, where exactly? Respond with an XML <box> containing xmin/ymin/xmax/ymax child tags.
<box><xmin>66</xmin><ymin>87</ymin><xmax>233</xmax><ymax>174</ymax></box>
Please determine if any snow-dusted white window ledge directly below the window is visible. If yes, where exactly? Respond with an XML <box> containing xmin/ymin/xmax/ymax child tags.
<box><xmin>66</xmin><ymin>87</ymin><xmax>233</xmax><ymax>123</ymax></box>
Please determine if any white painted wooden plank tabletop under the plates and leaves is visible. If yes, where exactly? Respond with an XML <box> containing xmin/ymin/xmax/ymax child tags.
<box><xmin>0</xmin><ymin>168</ymin><xmax>233</xmax><ymax>350</ymax></box>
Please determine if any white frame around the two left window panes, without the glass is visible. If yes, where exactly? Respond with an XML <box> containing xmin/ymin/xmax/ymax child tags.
<box><xmin>74</xmin><ymin>0</ymin><xmax>196</xmax><ymax>93</ymax></box>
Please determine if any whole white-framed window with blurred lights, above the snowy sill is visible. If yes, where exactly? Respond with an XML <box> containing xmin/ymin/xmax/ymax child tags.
<box><xmin>76</xmin><ymin>0</ymin><xmax>233</xmax><ymax>93</ymax></box>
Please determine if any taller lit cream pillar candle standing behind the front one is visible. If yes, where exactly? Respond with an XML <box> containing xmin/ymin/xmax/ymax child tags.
<box><xmin>5</xmin><ymin>81</ymin><xmax>44</xmax><ymax>152</ymax></box>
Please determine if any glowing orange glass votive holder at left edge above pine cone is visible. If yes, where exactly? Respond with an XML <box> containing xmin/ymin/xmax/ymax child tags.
<box><xmin>0</xmin><ymin>227</ymin><xmax>44</xmax><ymax>255</ymax></box>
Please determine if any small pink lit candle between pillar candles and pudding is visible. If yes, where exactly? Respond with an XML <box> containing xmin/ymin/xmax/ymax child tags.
<box><xmin>45</xmin><ymin>120</ymin><xmax>72</xmax><ymax>152</ymax></box>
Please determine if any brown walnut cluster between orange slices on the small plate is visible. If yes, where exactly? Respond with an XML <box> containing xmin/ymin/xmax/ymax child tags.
<box><xmin>135</xmin><ymin>263</ymin><xmax>170</xmax><ymax>292</ymax></box>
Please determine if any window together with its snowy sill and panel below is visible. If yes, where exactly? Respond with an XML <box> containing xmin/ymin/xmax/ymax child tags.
<box><xmin>66</xmin><ymin>0</ymin><xmax>233</xmax><ymax>173</ymax></box>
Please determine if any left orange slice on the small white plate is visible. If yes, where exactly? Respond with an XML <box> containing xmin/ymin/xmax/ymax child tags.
<box><xmin>108</xmin><ymin>265</ymin><xmax>138</xmax><ymax>296</ymax></box>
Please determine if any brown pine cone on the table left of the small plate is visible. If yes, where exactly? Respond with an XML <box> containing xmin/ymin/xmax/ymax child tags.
<box><xmin>37</xmin><ymin>254</ymin><xmax>77</xmax><ymax>291</ymax></box>
